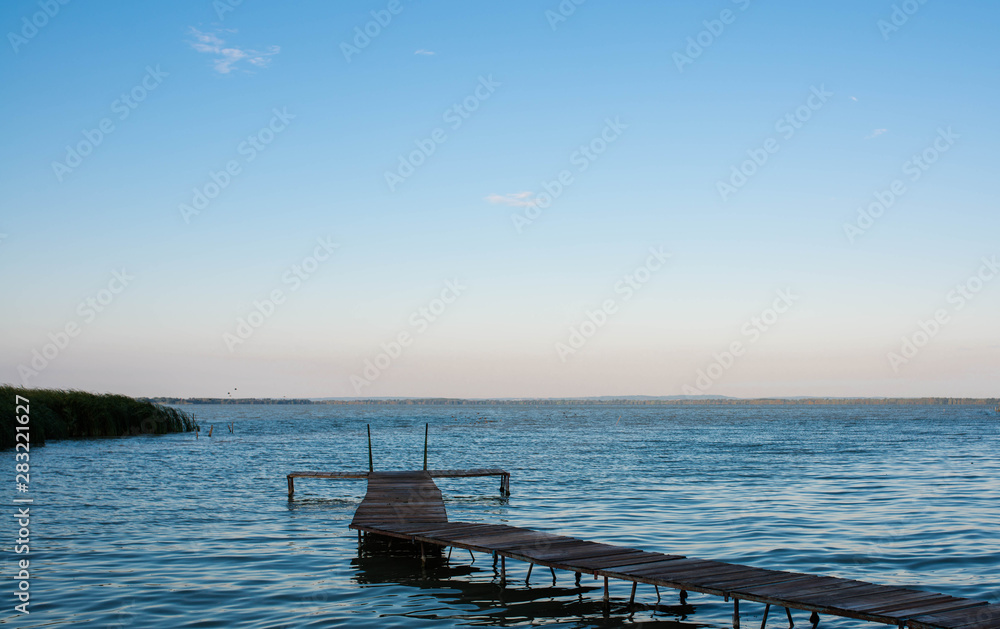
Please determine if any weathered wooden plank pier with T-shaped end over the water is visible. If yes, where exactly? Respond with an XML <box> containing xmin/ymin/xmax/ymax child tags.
<box><xmin>288</xmin><ymin>469</ymin><xmax>1000</xmax><ymax>629</ymax></box>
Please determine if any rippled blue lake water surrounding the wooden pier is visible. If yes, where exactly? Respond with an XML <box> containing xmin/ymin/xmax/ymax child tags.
<box><xmin>7</xmin><ymin>406</ymin><xmax>1000</xmax><ymax>628</ymax></box>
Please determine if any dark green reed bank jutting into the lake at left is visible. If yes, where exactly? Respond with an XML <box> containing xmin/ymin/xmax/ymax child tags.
<box><xmin>0</xmin><ymin>385</ymin><xmax>197</xmax><ymax>449</ymax></box>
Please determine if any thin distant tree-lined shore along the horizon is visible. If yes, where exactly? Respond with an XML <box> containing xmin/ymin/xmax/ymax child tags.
<box><xmin>148</xmin><ymin>396</ymin><xmax>1000</xmax><ymax>407</ymax></box>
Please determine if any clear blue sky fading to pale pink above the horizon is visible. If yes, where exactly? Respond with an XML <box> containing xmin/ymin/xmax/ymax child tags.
<box><xmin>0</xmin><ymin>0</ymin><xmax>1000</xmax><ymax>397</ymax></box>
